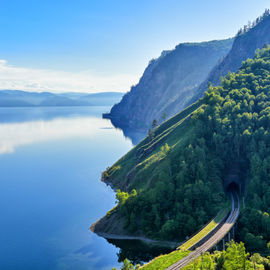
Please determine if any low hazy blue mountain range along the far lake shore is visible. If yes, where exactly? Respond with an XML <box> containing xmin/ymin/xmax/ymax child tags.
<box><xmin>0</xmin><ymin>90</ymin><xmax>123</xmax><ymax>107</ymax></box>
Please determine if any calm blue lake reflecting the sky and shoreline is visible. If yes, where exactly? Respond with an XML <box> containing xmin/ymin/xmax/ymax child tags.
<box><xmin>0</xmin><ymin>107</ymin><xmax>171</xmax><ymax>270</ymax></box>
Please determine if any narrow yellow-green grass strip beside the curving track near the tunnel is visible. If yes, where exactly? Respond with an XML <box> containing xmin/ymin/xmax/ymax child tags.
<box><xmin>179</xmin><ymin>209</ymin><xmax>228</xmax><ymax>250</ymax></box>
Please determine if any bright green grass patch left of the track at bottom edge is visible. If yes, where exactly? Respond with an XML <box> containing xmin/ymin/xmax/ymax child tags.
<box><xmin>140</xmin><ymin>250</ymin><xmax>190</xmax><ymax>270</ymax></box>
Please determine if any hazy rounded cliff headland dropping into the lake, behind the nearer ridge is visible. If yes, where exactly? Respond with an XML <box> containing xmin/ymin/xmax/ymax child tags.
<box><xmin>107</xmin><ymin>39</ymin><xmax>233</xmax><ymax>129</ymax></box>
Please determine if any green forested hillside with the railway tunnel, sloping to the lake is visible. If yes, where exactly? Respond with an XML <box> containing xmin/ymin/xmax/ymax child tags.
<box><xmin>92</xmin><ymin>48</ymin><xmax>270</xmax><ymax>252</ymax></box>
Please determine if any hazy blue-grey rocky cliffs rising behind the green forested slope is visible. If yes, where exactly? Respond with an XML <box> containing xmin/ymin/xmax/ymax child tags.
<box><xmin>106</xmin><ymin>11</ymin><xmax>270</xmax><ymax>133</ymax></box>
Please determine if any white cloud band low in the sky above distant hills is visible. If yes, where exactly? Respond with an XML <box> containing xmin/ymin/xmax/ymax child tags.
<box><xmin>0</xmin><ymin>60</ymin><xmax>138</xmax><ymax>92</ymax></box>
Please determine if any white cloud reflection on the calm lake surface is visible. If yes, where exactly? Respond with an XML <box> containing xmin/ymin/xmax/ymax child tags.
<box><xmin>0</xmin><ymin>117</ymin><xmax>111</xmax><ymax>154</ymax></box>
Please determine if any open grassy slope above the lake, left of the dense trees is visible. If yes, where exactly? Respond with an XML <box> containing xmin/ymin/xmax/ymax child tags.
<box><xmin>105</xmin><ymin>102</ymin><xmax>201</xmax><ymax>190</ymax></box>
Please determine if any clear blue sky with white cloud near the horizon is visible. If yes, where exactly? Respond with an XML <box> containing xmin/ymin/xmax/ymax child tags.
<box><xmin>0</xmin><ymin>0</ymin><xmax>270</xmax><ymax>92</ymax></box>
